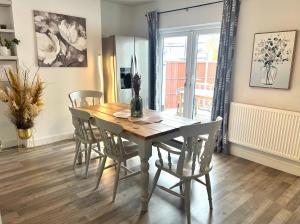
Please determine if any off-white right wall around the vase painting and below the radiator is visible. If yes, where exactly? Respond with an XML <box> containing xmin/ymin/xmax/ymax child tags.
<box><xmin>229</xmin><ymin>0</ymin><xmax>300</xmax><ymax>175</ymax></box>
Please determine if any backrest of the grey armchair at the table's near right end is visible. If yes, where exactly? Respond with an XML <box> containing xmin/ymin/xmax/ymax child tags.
<box><xmin>159</xmin><ymin>117</ymin><xmax>222</xmax><ymax>176</ymax></box>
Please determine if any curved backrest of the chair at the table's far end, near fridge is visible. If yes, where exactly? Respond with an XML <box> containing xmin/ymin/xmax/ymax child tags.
<box><xmin>69</xmin><ymin>90</ymin><xmax>103</xmax><ymax>108</ymax></box>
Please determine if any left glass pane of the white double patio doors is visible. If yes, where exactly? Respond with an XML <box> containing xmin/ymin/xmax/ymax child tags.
<box><xmin>162</xmin><ymin>36</ymin><xmax>187</xmax><ymax>116</ymax></box>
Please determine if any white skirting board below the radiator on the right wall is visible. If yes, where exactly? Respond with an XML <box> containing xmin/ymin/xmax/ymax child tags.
<box><xmin>230</xmin><ymin>143</ymin><xmax>300</xmax><ymax>176</ymax></box>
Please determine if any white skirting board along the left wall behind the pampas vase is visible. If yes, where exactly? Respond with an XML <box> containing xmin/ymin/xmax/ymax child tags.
<box><xmin>0</xmin><ymin>132</ymin><xmax>74</xmax><ymax>150</ymax></box>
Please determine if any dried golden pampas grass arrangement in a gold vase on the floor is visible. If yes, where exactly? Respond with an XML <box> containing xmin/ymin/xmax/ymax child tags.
<box><xmin>0</xmin><ymin>69</ymin><xmax>44</xmax><ymax>139</ymax></box>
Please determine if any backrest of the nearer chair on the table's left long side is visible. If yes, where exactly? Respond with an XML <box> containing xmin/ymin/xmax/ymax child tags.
<box><xmin>94</xmin><ymin>117</ymin><xmax>125</xmax><ymax>159</ymax></box>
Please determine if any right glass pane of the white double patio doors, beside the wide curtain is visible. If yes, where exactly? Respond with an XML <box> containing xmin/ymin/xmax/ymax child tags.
<box><xmin>194</xmin><ymin>34</ymin><xmax>220</xmax><ymax>121</ymax></box>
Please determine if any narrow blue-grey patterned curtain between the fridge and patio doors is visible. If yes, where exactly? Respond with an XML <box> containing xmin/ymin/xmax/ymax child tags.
<box><xmin>146</xmin><ymin>11</ymin><xmax>159</xmax><ymax>110</ymax></box>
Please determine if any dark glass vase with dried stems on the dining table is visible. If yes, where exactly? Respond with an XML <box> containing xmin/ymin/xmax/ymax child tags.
<box><xmin>130</xmin><ymin>73</ymin><xmax>143</xmax><ymax>118</ymax></box>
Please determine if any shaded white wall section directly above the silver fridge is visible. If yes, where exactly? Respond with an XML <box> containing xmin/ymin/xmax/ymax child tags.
<box><xmin>101</xmin><ymin>0</ymin><xmax>134</xmax><ymax>37</ymax></box>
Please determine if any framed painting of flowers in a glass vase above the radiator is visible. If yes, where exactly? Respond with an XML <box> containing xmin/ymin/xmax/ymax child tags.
<box><xmin>250</xmin><ymin>31</ymin><xmax>296</xmax><ymax>89</ymax></box>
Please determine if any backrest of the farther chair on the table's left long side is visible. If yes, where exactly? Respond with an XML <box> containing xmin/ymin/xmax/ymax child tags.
<box><xmin>69</xmin><ymin>107</ymin><xmax>95</xmax><ymax>141</ymax></box>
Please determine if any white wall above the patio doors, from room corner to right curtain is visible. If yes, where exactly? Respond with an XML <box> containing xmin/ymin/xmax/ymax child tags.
<box><xmin>133</xmin><ymin>0</ymin><xmax>223</xmax><ymax>37</ymax></box>
